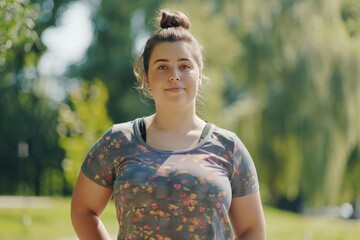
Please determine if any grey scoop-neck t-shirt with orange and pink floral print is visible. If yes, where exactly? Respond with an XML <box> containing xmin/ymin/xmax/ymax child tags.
<box><xmin>82</xmin><ymin>119</ymin><xmax>259</xmax><ymax>240</ymax></box>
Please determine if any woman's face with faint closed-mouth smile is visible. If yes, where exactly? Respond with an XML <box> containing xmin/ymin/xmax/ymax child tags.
<box><xmin>146</xmin><ymin>41</ymin><xmax>201</xmax><ymax>108</ymax></box>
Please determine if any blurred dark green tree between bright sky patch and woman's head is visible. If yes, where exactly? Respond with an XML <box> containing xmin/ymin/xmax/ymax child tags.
<box><xmin>71</xmin><ymin>0</ymin><xmax>163</xmax><ymax>122</ymax></box>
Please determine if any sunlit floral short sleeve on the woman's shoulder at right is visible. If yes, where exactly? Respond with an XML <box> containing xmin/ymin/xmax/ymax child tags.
<box><xmin>231</xmin><ymin>134</ymin><xmax>259</xmax><ymax>197</ymax></box>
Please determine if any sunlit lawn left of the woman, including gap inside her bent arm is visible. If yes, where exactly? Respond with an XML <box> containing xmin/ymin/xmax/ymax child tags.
<box><xmin>0</xmin><ymin>198</ymin><xmax>117</xmax><ymax>240</ymax></box>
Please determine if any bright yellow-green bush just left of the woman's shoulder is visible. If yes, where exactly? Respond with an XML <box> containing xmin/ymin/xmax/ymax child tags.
<box><xmin>57</xmin><ymin>80</ymin><xmax>112</xmax><ymax>185</ymax></box>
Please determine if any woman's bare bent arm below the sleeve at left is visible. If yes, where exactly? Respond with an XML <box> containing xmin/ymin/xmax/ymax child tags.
<box><xmin>71</xmin><ymin>173</ymin><xmax>112</xmax><ymax>240</ymax></box>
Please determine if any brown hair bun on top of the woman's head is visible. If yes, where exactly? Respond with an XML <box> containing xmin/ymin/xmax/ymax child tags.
<box><xmin>160</xmin><ymin>10</ymin><xmax>190</xmax><ymax>29</ymax></box>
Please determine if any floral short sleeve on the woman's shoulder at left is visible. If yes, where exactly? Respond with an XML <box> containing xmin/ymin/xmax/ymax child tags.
<box><xmin>81</xmin><ymin>128</ymin><xmax>115</xmax><ymax>188</ymax></box>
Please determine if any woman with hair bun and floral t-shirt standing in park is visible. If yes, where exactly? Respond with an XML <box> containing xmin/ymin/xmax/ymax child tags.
<box><xmin>71</xmin><ymin>8</ymin><xmax>265</xmax><ymax>240</ymax></box>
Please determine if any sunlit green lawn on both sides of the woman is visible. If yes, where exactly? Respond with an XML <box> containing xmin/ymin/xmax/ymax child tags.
<box><xmin>0</xmin><ymin>198</ymin><xmax>360</xmax><ymax>240</ymax></box>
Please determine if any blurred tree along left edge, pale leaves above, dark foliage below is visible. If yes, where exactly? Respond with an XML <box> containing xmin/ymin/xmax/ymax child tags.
<box><xmin>0</xmin><ymin>0</ymin><xmax>71</xmax><ymax>195</ymax></box>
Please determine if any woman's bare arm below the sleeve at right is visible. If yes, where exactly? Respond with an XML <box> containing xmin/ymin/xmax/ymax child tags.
<box><xmin>229</xmin><ymin>191</ymin><xmax>266</xmax><ymax>240</ymax></box>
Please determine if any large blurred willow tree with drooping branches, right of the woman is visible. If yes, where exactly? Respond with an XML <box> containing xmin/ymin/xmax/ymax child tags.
<box><xmin>214</xmin><ymin>0</ymin><xmax>360</xmax><ymax>210</ymax></box>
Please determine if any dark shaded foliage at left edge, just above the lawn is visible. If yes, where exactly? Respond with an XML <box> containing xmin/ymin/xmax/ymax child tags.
<box><xmin>0</xmin><ymin>85</ymin><xmax>63</xmax><ymax>195</ymax></box>
